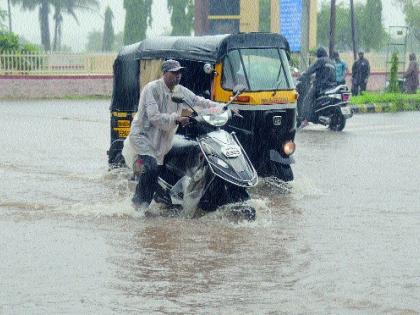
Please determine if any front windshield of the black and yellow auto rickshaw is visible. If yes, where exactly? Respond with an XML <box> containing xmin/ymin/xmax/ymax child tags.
<box><xmin>222</xmin><ymin>48</ymin><xmax>294</xmax><ymax>91</ymax></box>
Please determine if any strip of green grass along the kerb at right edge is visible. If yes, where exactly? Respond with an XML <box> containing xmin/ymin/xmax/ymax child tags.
<box><xmin>350</xmin><ymin>92</ymin><xmax>420</xmax><ymax>112</ymax></box>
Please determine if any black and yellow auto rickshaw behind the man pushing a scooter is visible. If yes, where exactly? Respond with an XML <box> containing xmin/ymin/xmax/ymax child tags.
<box><xmin>108</xmin><ymin>33</ymin><xmax>298</xmax><ymax>181</ymax></box>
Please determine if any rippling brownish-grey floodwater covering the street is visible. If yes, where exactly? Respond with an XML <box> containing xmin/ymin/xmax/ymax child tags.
<box><xmin>0</xmin><ymin>100</ymin><xmax>420</xmax><ymax>314</ymax></box>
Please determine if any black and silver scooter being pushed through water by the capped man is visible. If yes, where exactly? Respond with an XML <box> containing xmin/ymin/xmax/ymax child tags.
<box><xmin>148</xmin><ymin>86</ymin><xmax>258</xmax><ymax>221</ymax></box>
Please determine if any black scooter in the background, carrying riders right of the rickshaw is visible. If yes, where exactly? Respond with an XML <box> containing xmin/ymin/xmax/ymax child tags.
<box><xmin>296</xmin><ymin>73</ymin><xmax>353</xmax><ymax>131</ymax></box>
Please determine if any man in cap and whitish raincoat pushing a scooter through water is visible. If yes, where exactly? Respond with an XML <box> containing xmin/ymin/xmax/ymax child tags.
<box><xmin>122</xmin><ymin>59</ymin><xmax>224</xmax><ymax>209</ymax></box>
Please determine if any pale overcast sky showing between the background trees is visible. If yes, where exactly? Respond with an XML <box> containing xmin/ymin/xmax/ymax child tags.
<box><xmin>0</xmin><ymin>0</ymin><xmax>404</xmax><ymax>51</ymax></box>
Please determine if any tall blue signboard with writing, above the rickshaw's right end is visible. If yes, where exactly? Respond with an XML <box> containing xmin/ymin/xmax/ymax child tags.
<box><xmin>279</xmin><ymin>0</ymin><xmax>302</xmax><ymax>52</ymax></box>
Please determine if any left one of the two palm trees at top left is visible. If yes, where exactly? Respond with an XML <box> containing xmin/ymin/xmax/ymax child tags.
<box><xmin>11</xmin><ymin>0</ymin><xmax>51</xmax><ymax>51</ymax></box>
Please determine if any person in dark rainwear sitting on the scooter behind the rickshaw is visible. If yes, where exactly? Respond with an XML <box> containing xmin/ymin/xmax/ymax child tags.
<box><xmin>300</xmin><ymin>47</ymin><xmax>336</xmax><ymax>128</ymax></box>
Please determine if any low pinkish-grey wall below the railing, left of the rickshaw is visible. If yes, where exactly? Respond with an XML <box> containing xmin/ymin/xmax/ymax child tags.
<box><xmin>0</xmin><ymin>75</ymin><xmax>112</xmax><ymax>98</ymax></box>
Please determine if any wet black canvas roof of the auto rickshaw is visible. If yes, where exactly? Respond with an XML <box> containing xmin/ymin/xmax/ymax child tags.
<box><xmin>117</xmin><ymin>33</ymin><xmax>289</xmax><ymax>62</ymax></box>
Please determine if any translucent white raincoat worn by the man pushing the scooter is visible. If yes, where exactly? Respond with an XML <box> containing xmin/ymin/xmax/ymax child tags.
<box><xmin>122</xmin><ymin>78</ymin><xmax>223</xmax><ymax>168</ymax></box>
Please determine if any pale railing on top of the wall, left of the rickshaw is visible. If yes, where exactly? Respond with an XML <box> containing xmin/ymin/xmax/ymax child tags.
<box><xmin>0</xmin><ymin>51</ymin><xmax>117</xmax><ymax>75</ymax></box>
